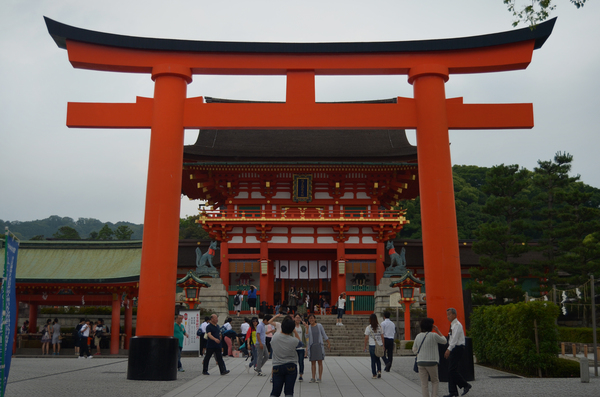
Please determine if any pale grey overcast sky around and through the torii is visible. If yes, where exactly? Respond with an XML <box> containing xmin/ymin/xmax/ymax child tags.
<box><xmin>0</xmin><ymin>0</ymin><xmax>600</xmax><ymax>223</ymax></box>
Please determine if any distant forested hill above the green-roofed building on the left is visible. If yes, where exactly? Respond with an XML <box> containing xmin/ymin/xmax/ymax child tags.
<box><xmin>0</xmin><ymin>215</ymin><xmax>144</xmax><ymax>240</ymax></box>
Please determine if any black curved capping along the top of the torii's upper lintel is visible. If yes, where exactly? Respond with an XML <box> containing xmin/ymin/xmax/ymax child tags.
<box><xmin>44</xmin><ymin>17</ymin><xmax>556</xmax><ymax>54</ymax></box>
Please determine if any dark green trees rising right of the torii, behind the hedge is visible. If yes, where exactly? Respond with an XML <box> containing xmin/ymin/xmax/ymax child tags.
<box><xmin>399</xmin><ymin>152</ymin><xmax>600</xmax><ymax>303</ymax></box>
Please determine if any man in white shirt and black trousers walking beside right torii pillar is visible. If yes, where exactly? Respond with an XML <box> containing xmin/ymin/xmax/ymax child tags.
<box><xmin>444</xmin><ymin>308</ymin><xmax>471</xmax><ymax>397</ymax></box>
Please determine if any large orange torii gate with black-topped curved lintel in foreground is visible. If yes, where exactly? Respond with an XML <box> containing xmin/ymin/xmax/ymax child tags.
<box><xmin>46</xmin><ymin>18</ymin><xmax>555</xmax><ymax>380</ymax></box>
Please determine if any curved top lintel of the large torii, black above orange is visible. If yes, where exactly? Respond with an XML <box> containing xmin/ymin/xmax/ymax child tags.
<box><xmin>44</xmin><ymin>17</ymin><xmax>556</xmax><ymax>75</ymax></box>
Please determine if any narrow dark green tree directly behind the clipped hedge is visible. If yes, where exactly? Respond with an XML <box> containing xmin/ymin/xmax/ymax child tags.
<box><xmin>470</xmin><ymin>164</ymin><xmax>530</xmax><ymax>304</ymax></box>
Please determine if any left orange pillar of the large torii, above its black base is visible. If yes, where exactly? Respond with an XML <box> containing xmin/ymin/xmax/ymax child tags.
<box><xmin>136</xmin><ymin>65</ymin><xmax>191</xmax><ymax>336</ymax></box>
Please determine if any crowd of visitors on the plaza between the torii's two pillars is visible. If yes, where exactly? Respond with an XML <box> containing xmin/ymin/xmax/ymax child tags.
<box><xmin>175</xmin><ymin>302</ymin><xmax>471</xmax><ymax>397</ymax></box>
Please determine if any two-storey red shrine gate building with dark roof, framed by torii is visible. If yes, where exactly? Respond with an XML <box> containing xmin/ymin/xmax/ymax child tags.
<box><xmin>182</xmin><ymin>98</ymin><xmax>419</xmax><ymax>312</ymax></box>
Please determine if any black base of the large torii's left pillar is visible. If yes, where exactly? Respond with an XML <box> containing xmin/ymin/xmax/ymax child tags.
<box><xmin>127</xmin><ymin>336</ymin><xmax>179</xmax><ymax>380</ymax></box>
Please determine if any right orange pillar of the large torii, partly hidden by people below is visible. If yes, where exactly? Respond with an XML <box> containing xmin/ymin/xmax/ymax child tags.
<box><xmin>408</xmin><ymin>65</ymin><xmax>464</xmax><ymax>333</ymax></box>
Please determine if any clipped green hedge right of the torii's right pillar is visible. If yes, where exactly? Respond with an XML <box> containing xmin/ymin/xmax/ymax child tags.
<box><xmin>470</xmin><ymin>302</ymin><xmax>559</xmax><ymax>376</ymax></box>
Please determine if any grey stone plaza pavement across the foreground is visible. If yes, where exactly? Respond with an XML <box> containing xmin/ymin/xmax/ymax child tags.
<box><xmin>6</xmin><ymin>356</ymin><xmax>600</xmax><ymax>397</ymax></box>
